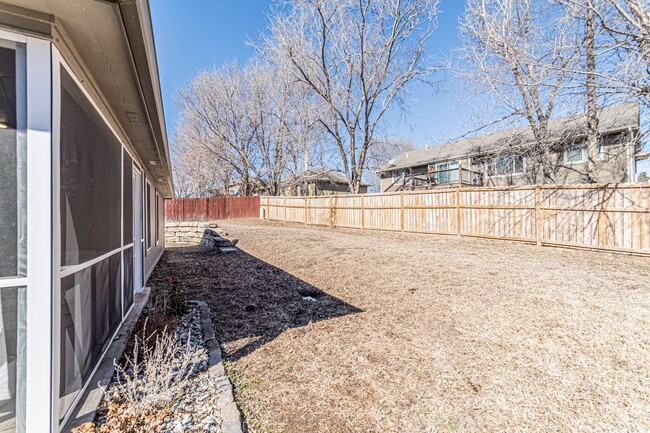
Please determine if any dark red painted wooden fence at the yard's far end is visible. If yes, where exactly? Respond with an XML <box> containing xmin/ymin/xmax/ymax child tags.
<box><xmin>165</xmin><ymin>197</ymin><xmax>260</xmax><ymax>221</ymax></box>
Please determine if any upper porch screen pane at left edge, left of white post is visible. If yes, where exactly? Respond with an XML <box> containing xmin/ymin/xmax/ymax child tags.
<box><xmin>0</xmin><ymin>45</ymin><xmax>27</xmax><ymax>278</ymax></box>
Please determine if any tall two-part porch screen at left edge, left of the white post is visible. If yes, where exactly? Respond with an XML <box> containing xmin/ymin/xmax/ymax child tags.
<box><xmin>0</xmin><ymin>40</ymin><xmax>27</xmax><ymax>433</ymax></box>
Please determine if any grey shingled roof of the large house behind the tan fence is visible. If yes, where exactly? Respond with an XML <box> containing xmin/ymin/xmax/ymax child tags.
<box><xmin>378</xmin><ymin>103</ymin><xmax>640</xmax><ymax>172</ymax></box>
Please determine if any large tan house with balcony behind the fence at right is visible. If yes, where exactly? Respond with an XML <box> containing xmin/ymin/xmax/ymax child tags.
<box><xmin>377</xmin><ymin>104</ymin><xmax>647</xmax><ymax>192</ymax></box>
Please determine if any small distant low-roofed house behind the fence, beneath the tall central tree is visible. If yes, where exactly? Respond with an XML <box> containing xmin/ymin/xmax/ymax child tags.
<box><xmin>280</xmin><ymin>168</ymin><xmax>370</xmax><ymax>196</ymax></box>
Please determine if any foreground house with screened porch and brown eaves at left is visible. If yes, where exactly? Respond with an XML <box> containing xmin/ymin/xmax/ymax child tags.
<box><xmin>0</xmin><ymin>0</ymin><xmax>173</xmax><ymax>433</ymax></box>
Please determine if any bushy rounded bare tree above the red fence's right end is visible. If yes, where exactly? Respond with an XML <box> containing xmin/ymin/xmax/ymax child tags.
<box><xmin>178</xmin><ymin>60</ymin><xmax>314</xmax><ymax>195</ymax></box>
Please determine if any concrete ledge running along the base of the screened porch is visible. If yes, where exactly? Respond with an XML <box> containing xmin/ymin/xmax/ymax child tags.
<box><xmin>61</xmin><ymin>287</ymin><xmax>151</xmax><ymax>433</ymax></box>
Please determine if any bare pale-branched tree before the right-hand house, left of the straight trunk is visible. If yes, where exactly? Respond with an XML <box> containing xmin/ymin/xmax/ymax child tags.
<box><xmin>457</xmin><ymin>0</ymin><xmax>582</xmax><ymax>183</ymax></box>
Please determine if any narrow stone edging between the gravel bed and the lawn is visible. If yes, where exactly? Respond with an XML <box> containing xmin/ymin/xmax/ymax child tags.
<box><xmin>188</xmin><ymin>301</ymin><xmax>243</xmax><ymax>433</ymax></box>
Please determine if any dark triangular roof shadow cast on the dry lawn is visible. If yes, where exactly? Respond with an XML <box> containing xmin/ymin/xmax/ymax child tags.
<box><xmin>156</xmin><ymin>247</ymin><xmax>362</xmax><ymax>360</ymax></box>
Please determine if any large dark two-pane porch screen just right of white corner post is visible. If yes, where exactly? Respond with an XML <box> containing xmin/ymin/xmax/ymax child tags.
<box><xmin>57</xmin><ymin>67</ymin><xmax>126</xmax><ymax>419</ymax></box>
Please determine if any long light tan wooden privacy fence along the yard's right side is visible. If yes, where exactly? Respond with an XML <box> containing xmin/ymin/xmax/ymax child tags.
<box><xmin>260</xmin><ymin>184</ymin><xmax>650</xmax><ymax>255</ymax></box>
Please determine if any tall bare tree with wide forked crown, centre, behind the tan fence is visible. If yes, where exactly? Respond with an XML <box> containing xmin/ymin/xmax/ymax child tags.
<box><xmin>260</xmin><ymin>0</ymin><xmax>438</xmax><ymax>192</ymax></box>
